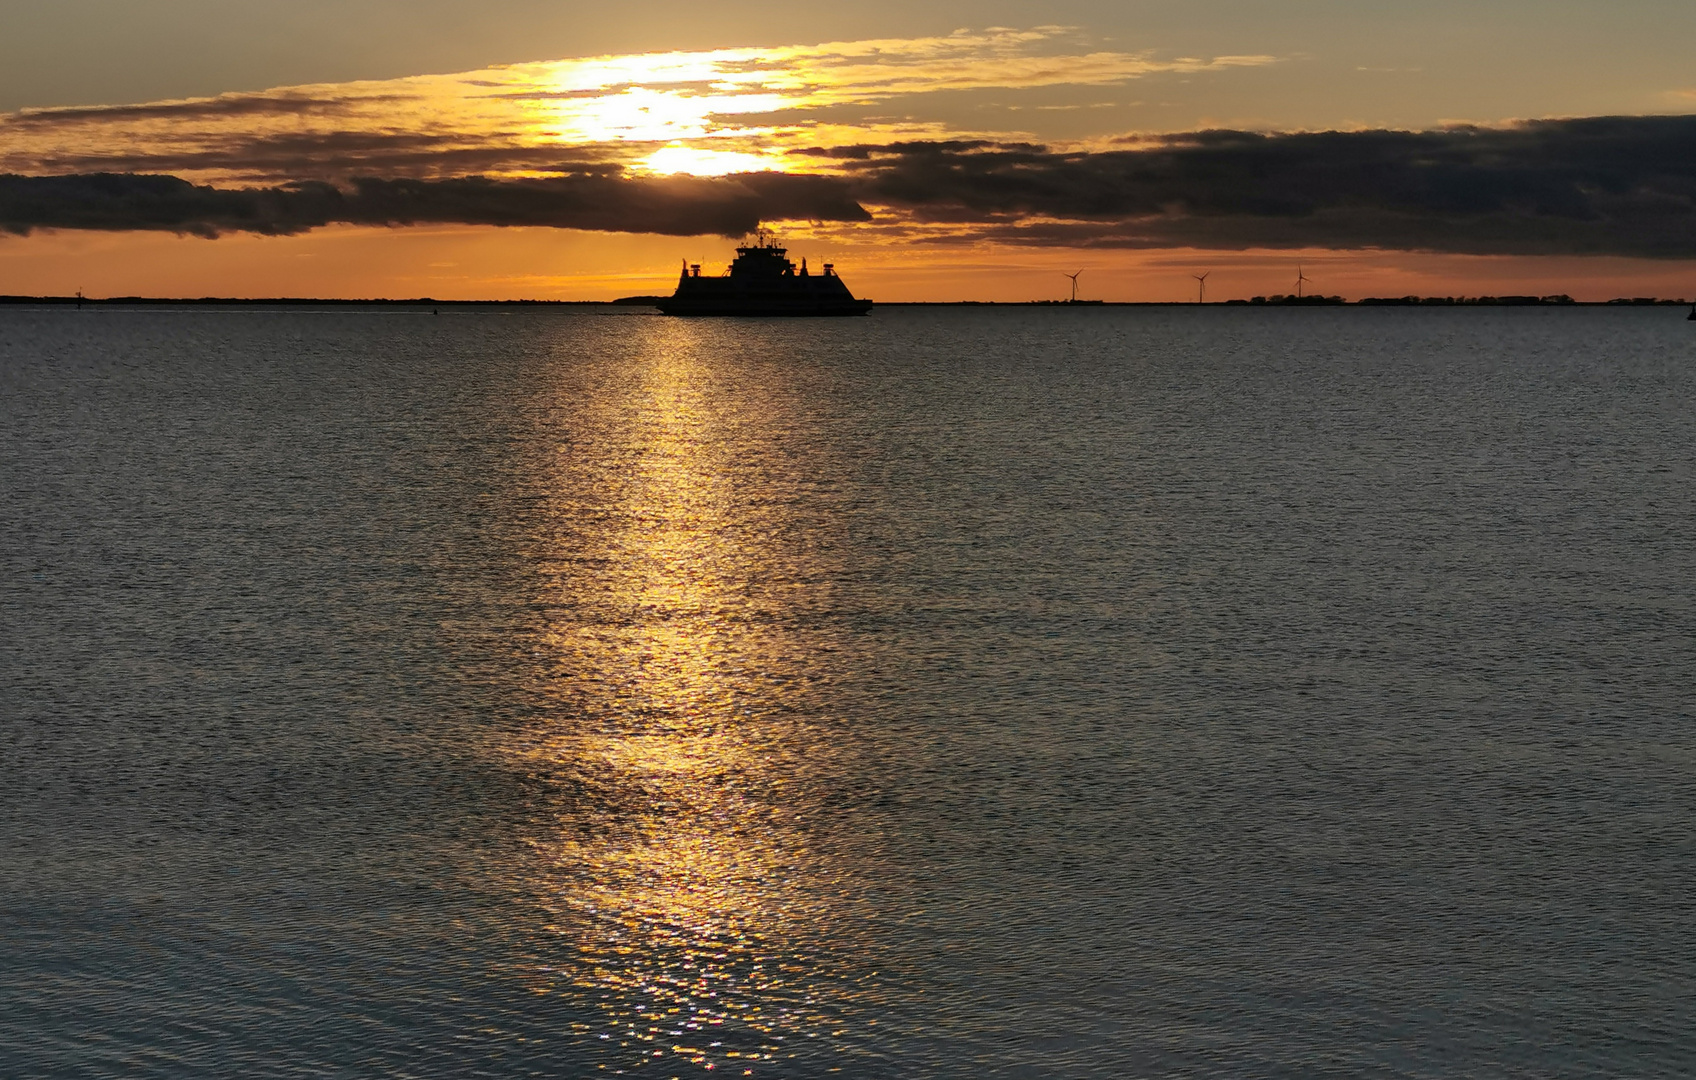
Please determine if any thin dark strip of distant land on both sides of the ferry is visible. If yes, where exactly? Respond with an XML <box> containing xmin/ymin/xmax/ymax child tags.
<box><xmin>0</xmin><ymin>295</ymin><xmax>1693</xmax><ymax>309</ymax></box>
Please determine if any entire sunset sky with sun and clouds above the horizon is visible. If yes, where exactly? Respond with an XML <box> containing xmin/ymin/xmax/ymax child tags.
<box><xmin>0</xmin><ymin>0</ymin><xmax>1696</xmax><ymax>300</ymax></box>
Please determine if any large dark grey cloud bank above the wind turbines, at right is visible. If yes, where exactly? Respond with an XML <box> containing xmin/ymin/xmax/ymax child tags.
<box><xmin>841</xmin><ymin>117</ymin><xmax>1696</xmax><ymax>258</ymax></box>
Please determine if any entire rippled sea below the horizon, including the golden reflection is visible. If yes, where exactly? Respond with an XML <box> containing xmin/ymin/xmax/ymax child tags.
<box><xmin>0</xmin><ymin>309</ymin><xmax>1696</xmax><ymax>1078</ymax></box>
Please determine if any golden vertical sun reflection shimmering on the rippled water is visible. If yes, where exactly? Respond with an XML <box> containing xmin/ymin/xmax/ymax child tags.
<box><xmin>508</xmin><ymin>324</ymin><xmax>875</xmax><ymax>1075</ymax></box>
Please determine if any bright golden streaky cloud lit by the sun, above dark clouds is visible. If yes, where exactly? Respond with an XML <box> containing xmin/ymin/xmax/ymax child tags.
<box><xmin>0</xmin><ymin>27</ymin><xmax>1275</xmax><ymax>183</ymax></box>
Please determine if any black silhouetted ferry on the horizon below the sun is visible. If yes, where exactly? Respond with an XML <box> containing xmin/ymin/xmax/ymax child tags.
<box><xmin>655</xmin><ymin>229</ymin><xmax>872</xmax><ymax>315</ymax></box>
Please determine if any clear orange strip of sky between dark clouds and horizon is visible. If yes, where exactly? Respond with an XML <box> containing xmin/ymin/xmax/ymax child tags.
<box><xmin>0</xmin><ymin>225</ymin><xmax>1696</xmax><ymax>302</ymax></box>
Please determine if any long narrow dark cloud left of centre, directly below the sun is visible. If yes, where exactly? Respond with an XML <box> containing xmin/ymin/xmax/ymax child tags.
<box><xmin>0</xmin><ymin>173</ymin><xmax>870</xmax><ymax>237</ymax></box>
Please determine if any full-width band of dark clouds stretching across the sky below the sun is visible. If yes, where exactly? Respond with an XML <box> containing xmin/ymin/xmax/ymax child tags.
<box><xmin>0</xmin><ymin>117</ymin><xmax>1696</xmax><ymax>259</ymax></box>
